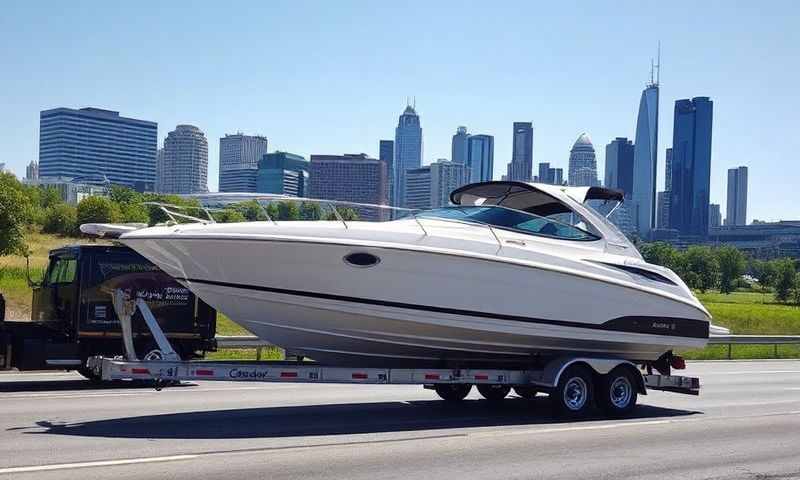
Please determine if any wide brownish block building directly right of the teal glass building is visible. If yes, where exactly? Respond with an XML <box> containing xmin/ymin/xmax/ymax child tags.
<box><xmin>308</xmin><ymin>153</ymin><xmax>389</xmax><ymax>220</ymax></box>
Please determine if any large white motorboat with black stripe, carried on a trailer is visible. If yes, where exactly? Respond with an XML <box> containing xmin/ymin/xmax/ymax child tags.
<box><xmin>111</xmin><ymin>181</ymin><xmax>711</xmax><ymax>367</ymax></box>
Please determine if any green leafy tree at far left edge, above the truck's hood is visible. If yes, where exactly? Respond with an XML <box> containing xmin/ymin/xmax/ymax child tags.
<box><xmin>0</xmin><ymin>173</ymin><xmax>32</xmax><ymax>256</ymax></box>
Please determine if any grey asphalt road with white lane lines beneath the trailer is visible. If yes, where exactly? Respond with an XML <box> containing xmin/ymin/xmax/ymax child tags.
<box><xmin>0</xmin><ymin>361</ymin><xmax>800</xmax><ymax>480</ymax></box>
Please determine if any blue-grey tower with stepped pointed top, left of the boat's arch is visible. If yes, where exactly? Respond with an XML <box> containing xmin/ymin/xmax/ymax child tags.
<box><xmin>393</xmin><ymin>105</ymin><xmax>422</xmax><ymax>207</ymax></box>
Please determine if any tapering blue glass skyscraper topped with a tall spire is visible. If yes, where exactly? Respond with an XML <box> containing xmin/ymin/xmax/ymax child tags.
<box><xmin>632</xmin><ymin>75</ymin><xmax>659</xmax><ymax>238</ymax></box>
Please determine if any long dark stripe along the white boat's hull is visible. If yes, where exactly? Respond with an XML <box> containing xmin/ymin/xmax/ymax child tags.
<box><xmin>181</xmin><ymin>278</ymin><xmax>708</xmax><ymax>338</ymax></box>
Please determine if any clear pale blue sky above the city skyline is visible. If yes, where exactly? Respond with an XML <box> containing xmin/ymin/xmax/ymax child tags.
<box><xmin>0</xmin><ymin>0</ymin><xmax>800</xmax><ymax>220</ymax></box>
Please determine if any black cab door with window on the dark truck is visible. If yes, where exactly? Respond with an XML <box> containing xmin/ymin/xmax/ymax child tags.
<box><xmin>32</xmin><ymin>256</ymin><xmax>78</xmax><ymax>322</ymax></box>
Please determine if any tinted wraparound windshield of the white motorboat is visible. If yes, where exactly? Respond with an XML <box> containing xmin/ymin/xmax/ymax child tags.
<box><xmin>417</xmin><ymin>205</ymin><xmax>600</xmax><ymax>241</ymax></box>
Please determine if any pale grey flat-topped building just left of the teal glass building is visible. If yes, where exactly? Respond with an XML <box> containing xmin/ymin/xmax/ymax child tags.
<box><xmin>219</xmin><ymin>133</ymin><xmax>267</xmax><ymax>192</ymax></box>
